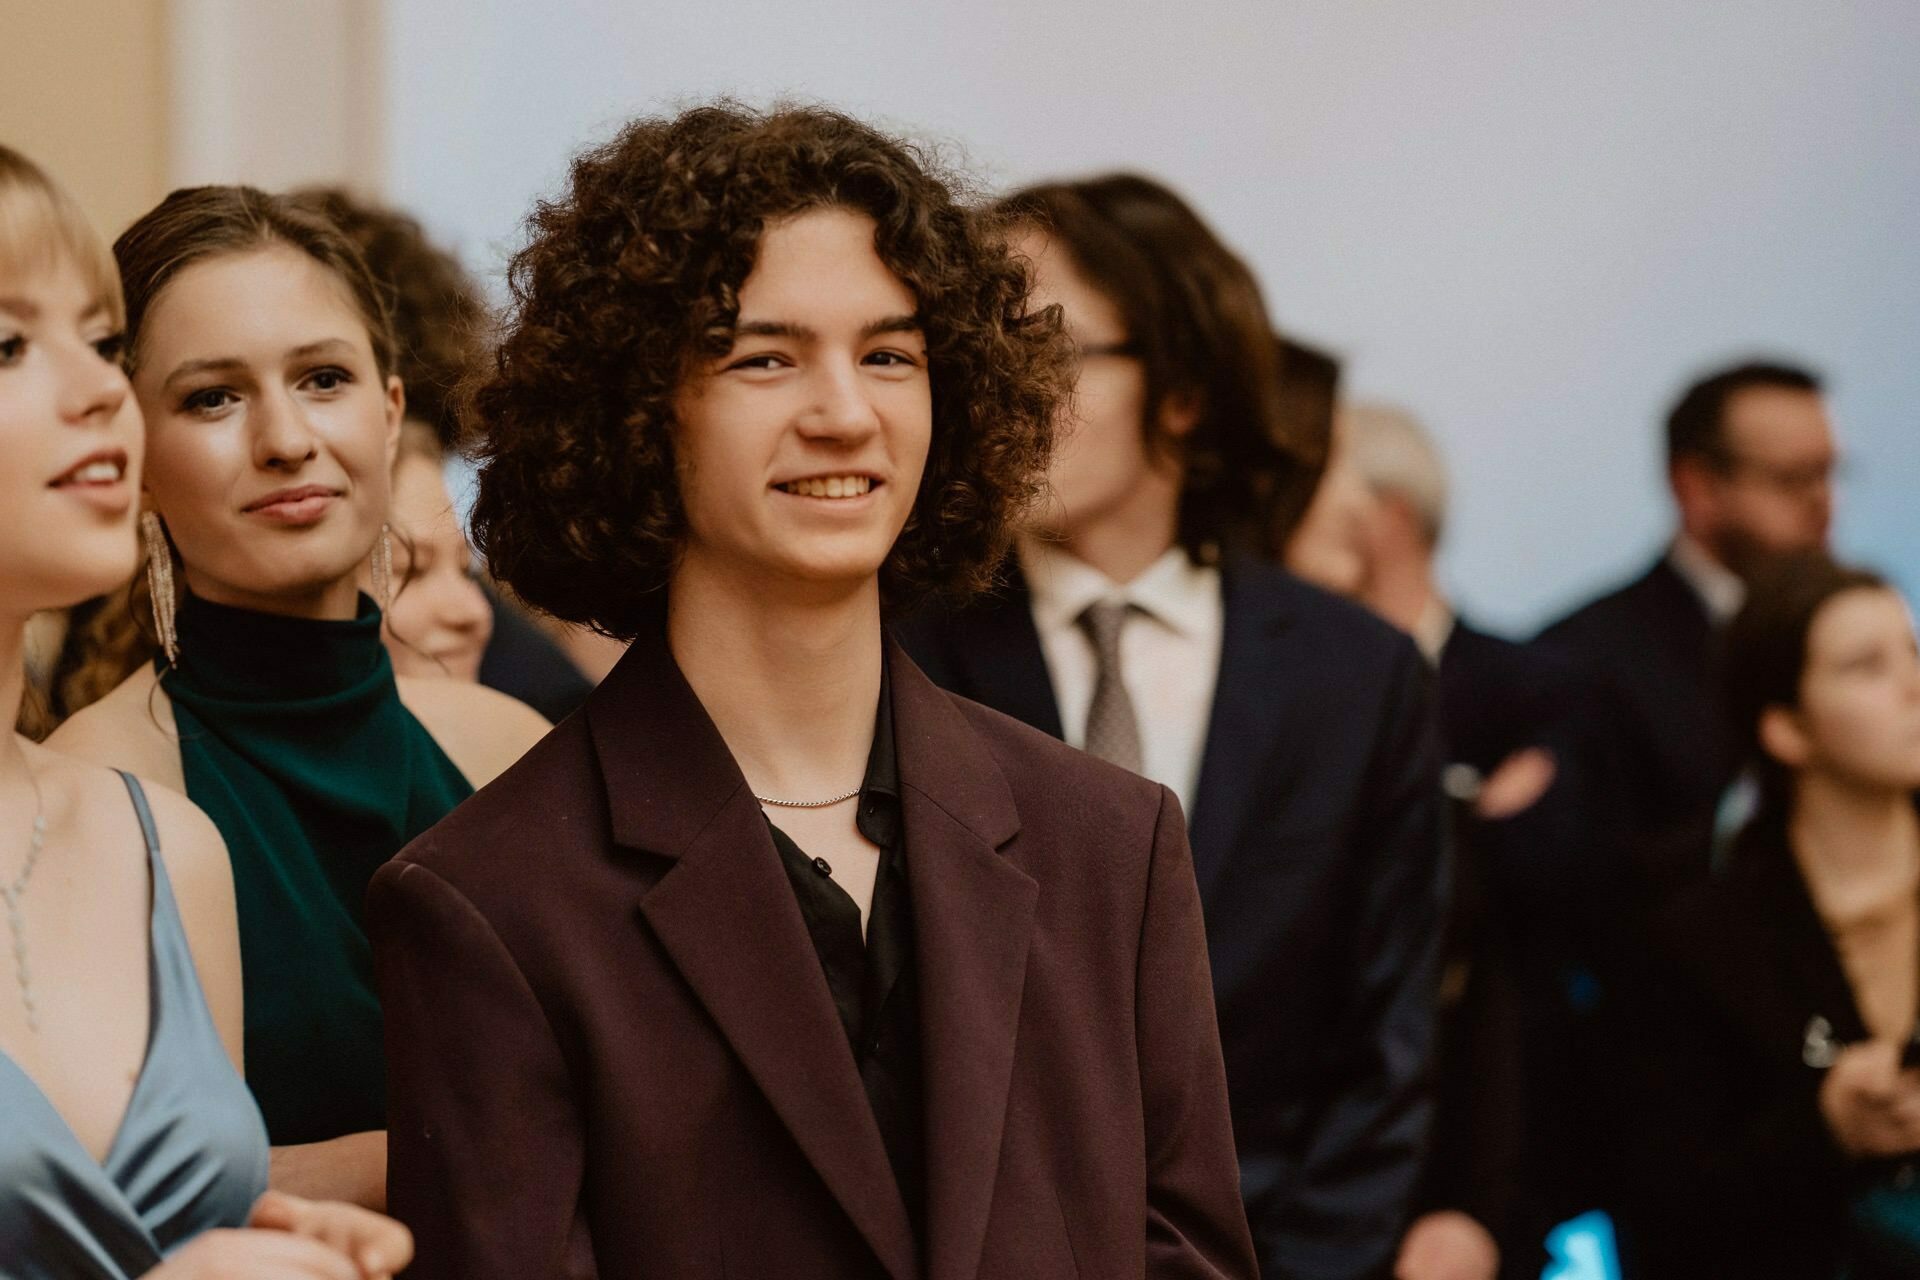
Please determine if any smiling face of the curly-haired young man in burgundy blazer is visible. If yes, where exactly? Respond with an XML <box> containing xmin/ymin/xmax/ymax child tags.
<box><xmin>674</xmin><ymin>209</ymin><xmax>933</xmax><ymax>606</ymax></box>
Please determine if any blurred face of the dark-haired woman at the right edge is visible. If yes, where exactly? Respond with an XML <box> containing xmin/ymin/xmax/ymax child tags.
<box><xmin>1761</xmin><ymin>587</ymin><xmax>1920</xmax><ymax>791</ymax></box>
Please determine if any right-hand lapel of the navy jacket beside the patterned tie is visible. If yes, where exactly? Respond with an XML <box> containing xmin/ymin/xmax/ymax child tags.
<box><xmin>1187</xmin><ymin>557</ymin><xmax>1288</xmax><ymax>900</ymax></box>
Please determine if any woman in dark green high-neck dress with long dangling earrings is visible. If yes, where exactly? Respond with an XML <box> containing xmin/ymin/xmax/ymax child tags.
<box><xmin>54</xmin><ymin>186</ymin><xmax>547</xmax><ymax>1207</ymax></box>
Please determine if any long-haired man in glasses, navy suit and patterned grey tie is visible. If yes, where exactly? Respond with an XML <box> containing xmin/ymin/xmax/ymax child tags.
<box><xmin>899</xmin><ymin>177</ymin><xmax>1444</xmax><ymax>1280</ymax></box>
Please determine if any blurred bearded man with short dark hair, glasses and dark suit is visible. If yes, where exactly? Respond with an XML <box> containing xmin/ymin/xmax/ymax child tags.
<box><xmin>1536</xmin><ymin>363</ymin><xmax>1837</xmax><ymax>1266</ymax></box>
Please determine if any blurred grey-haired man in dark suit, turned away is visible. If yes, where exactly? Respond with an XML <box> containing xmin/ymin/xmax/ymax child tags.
<box><xmin>1288</xmin><ymin>403</ymin><xmax>1590</xmax><ymax>1280</ymax></box>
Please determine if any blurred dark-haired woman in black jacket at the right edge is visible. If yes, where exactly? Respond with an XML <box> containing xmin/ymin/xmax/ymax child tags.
<box><xmin>1620</xmin><ymin>553</ymin><xmax>1920</xmax><ymax>1280</ymax></box>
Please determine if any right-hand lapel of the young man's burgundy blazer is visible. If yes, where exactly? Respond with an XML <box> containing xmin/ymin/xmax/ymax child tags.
<box><xmin>889</xmin><ymin>647</ymin><xmax>1039</xmax><ymax>1280</ymax></box>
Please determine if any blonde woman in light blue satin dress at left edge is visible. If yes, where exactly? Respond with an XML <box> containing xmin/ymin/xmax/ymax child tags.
<box><xmin>0</xmin><ymin>146</ymin><xmax>411</xmax><ymax>1280</ymax></box>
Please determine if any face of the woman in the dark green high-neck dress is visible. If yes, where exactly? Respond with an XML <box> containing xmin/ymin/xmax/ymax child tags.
<box><xmin>134</xmin><ymin>246</ymin><xmax>403</xmax><ymax>618</ymax></box>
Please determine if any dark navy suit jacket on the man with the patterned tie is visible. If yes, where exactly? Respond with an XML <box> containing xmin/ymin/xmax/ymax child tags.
<box><xmin>897</xmin><ymin>557</ymin><xmax>1446</xmax><ymax>1280</ymax></box>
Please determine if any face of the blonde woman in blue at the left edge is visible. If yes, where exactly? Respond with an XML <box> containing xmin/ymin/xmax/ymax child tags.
<box><xmin>0</xmin><ymin>253</ymin><xmax>142</xmax><ymax>616</ymax></box>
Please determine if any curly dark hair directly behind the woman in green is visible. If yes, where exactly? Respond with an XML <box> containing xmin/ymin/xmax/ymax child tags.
<box><xmin>290</xmin><ymin>186</ymin><xmax>488</xmax><ymax>451</ymax></box>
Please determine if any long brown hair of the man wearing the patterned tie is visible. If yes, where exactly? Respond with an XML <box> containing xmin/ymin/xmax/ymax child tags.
<box><xmin>1000</xmin><ymin>173</ymin><xmax>1331</xmax><ymax>562</ymax></box>
